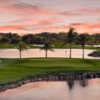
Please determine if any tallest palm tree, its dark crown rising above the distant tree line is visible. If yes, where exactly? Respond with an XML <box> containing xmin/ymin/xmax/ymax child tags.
<box><xmin>66</xmin><ymin>28</ymin><xmax>77</xmax><ymax>59</ymax></box>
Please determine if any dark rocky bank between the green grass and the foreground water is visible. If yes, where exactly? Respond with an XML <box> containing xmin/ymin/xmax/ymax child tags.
<box><xmin>0</xmin><ymin>72</ymin><xmax>100</xmax><ymax>92</ymax></box>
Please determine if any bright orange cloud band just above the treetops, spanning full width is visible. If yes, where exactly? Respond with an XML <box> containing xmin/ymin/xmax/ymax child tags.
<box><xmin>0</xmin><ymin>24</ymin><xmax>100</xmax><ymax>34</ymax></box>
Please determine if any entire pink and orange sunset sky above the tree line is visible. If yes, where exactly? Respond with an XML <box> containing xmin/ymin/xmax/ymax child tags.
<box><xmin>0</xmin><ymin>0</ymin><xmax>100</xmax><ymax>33</ymax></box>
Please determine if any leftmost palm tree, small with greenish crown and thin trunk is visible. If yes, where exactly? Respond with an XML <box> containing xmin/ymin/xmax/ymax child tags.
<box><xmin>17</xmin><ymin>41</ymin><xmax>28</xmax><ymax>60</ymax></box>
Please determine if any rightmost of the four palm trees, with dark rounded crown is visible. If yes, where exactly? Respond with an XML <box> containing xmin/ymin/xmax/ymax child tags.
<box><xmin>78</xmin><ymin>34</ymin><xmax>88</xmax><ymax>60</ymax></box>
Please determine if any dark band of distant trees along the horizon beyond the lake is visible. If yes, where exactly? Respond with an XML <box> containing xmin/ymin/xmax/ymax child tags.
<box><xmin>0</xmin><ymin>28</ymin><xmax>100</xmax><ymax>45</ymax></box>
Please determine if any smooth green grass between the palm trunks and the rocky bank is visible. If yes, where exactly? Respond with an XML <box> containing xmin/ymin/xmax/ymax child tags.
<box><xmin>0</xmin><ymin>58</ymin><xmax>100</xmax><ymax>84</ymax></box>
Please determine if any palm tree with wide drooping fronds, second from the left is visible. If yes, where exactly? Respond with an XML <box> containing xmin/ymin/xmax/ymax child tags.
<box><xmin>40</xmin><ymin>39</ymin><xmax>53</xmax><ymax>59</ymax></box>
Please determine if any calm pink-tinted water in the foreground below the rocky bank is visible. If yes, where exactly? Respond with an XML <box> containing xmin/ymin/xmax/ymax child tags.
<box><xmin>0</xmin><ymin>78</ymin><xmax>100</xmax><ymax>100</ymax></box>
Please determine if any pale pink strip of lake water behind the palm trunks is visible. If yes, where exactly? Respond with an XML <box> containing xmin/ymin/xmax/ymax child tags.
<box><xmin>0</xmin><ymin>49</ymin><xmax>100</xmax><ymax>59</ymax></box>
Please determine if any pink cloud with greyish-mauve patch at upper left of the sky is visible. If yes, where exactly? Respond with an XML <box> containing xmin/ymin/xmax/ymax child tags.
<box><xmin>0</xmin><ymin>2</ymin><xmax>56</xmax><ymax>17</ymax></box>
